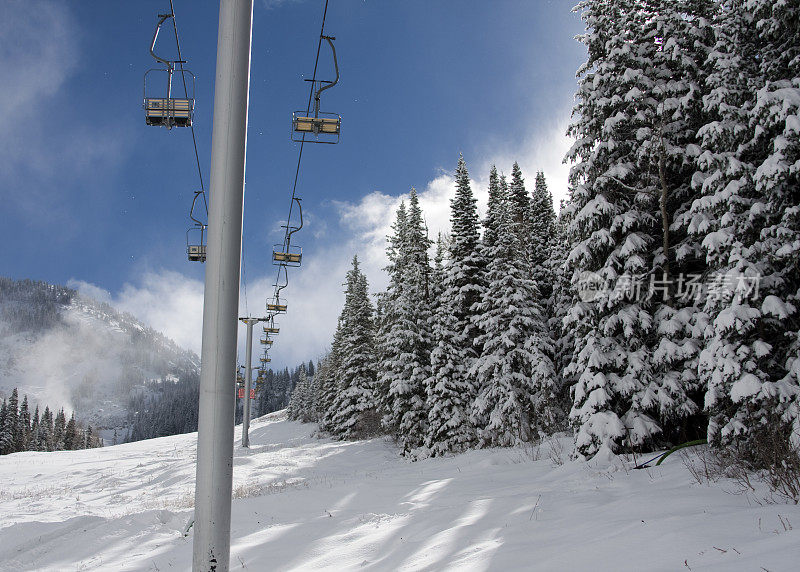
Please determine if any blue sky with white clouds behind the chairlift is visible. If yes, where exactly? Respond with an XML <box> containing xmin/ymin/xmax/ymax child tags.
<box><xmin>0</xmin><ymin>0</ymin><xmax>585</xmax><ymax>365</ymax></box>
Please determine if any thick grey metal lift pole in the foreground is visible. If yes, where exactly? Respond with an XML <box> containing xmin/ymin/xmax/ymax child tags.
<box><xmin>192</xmin><ymin>0</ymin><xmax>253</xmax><ymax>572</ymax></box>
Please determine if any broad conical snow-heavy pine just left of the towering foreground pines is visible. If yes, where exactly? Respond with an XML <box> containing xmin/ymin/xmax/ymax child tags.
<box><xmin>469</xmin><ymin>175</ymin><xmax>557</xmax><ymax>446</ymax></box>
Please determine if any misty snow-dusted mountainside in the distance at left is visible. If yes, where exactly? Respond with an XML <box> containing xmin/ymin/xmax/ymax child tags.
<box><xmin>0</xmin><ymin>278</ymin><xmax>200</xmax><ymax>428</ymax></box>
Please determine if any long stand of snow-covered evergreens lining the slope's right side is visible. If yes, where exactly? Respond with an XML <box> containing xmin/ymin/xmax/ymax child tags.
<box><xmin>290</xmin><ymin>0</ymin><xmax>800</xmax><ymax>464</ymax></box>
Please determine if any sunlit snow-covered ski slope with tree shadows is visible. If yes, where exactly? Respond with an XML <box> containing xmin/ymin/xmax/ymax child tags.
<box><xmin>0</xmin><ymin>413</ymin><xmax>800</xmax><ymax>572</ymax></box>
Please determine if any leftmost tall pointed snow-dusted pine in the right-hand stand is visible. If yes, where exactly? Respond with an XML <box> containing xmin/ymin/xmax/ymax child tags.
<box><xmin>332</xmin><ymin>256</ymin><xmax>380</xmax><ymax>439</ymax></box>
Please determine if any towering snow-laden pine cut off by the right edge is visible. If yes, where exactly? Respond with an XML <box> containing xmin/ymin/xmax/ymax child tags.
<box><xmin>692</xmin><ymin>0</ymin><xmax>800</xmax><ymax>450</ymax></box>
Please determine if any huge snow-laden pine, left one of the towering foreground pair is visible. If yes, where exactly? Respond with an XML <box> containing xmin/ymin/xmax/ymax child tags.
<box><xmin>567</xmin><ymin>0</ymin><xmax>710</xmax><ymax>455</ymax></box>
